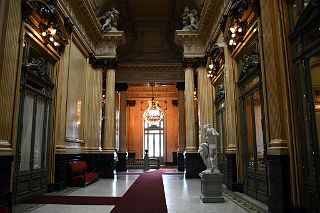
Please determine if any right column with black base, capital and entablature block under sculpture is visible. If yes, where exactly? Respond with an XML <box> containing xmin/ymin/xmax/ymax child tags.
<box><xmin>175</xmin><ymin>30</ymin><xmax>205</xmax><ymax>178</ymax></box>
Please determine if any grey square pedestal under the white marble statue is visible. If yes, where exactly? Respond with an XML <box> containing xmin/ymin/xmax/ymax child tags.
<box><xmin>199</xmin><ymin>172</ymin><xmax>224</xmax><ymax>203</ymax></box>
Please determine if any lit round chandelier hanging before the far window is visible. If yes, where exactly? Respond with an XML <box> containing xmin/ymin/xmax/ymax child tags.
<box><xmin>143</xmin><ymin>86</ymin><xmax>163</xmax><ymax>125</ymax></box>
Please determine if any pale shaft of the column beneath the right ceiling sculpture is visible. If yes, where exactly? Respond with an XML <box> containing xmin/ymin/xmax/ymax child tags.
<box><xmin>185</xmin><ymin>67</ymin><xmax>198</xmax><ymax>153</ymax></box>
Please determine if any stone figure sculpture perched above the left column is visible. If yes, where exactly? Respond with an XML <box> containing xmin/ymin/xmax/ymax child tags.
<box><xmin>98</xmin><ymin>7</ymin><xmax>119</xmax><ymax>32</ymax></box>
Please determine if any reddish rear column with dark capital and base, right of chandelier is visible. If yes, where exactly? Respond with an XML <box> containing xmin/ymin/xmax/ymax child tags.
<box><xmin>177</xmin><ymin>82</ymin><xmax>186</xmax><ymax>171</ymax></box>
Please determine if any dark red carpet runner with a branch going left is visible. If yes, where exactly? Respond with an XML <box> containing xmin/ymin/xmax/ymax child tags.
<box><xmin>31</xmin><ymin>169</ymin><xmax>176</xmax><ymax>213</ymax></box>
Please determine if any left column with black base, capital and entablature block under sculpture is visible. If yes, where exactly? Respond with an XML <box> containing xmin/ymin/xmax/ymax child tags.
<box><xmin>89</xmin><ymin>31</ymin><xmax>125</xmax><ymax>178</ymax></box>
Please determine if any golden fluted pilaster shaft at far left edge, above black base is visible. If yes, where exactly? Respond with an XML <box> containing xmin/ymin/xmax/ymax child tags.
<box><xmin>0</xmin><ymin>0</ymin><xmax>23</xmax><ymax>155</ymax></box>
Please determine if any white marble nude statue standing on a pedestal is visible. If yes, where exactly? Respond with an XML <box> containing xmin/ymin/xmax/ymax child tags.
<box><xmin>199</xmin><ymin>124</ymin><xmax>220</xmax><ymax>173</ymax></box>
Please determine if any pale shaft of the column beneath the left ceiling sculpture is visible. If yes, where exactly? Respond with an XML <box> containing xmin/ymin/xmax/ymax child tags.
<box><xmin>103</xmin><ymin>69</ymin><xmax>115</xmax><ymax>153</ymax></box>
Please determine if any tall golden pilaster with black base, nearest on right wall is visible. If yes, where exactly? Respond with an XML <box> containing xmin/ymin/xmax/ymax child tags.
<box><xmin>259</xmin><ymin>0</ymin><xmax>296</xmax><ymax>212</ymax></box>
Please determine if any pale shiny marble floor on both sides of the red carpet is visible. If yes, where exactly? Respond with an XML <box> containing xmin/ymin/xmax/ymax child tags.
<box><xmin>13</xmin><ymin>171</ymin><xmax>260</xmax><ymax>213</ymax></box>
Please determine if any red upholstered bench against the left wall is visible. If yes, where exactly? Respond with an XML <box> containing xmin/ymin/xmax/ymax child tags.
<box><xmin>70</xmin><ymin>161</ymin><xmax>99</xmax><ymax>186</ymax></box>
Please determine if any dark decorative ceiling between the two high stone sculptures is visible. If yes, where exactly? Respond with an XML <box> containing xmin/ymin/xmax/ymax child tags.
<box><xmin>90</xmin><ymin>0</ymin><xmax>204</xmax><ymax>83</ymax></box>
